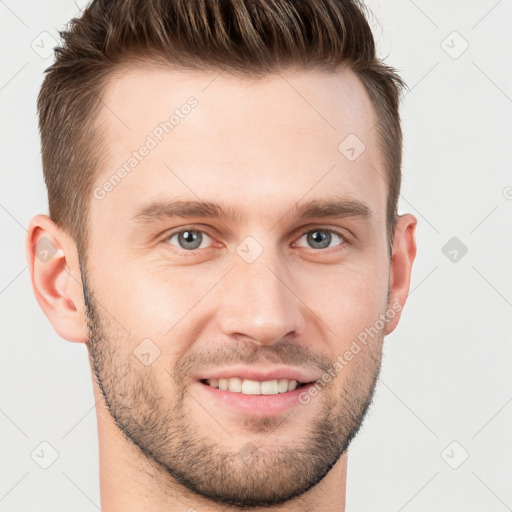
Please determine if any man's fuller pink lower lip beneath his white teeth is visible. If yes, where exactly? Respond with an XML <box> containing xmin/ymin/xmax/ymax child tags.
<box><xmin>197</xmin><ymin>382</ymin><xmax>314</xmax><ymax>416</ymax></box>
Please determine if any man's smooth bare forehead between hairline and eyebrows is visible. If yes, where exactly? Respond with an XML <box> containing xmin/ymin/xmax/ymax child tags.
<box><xmin>91</xmin><ymin>65</ymin><xmax>386</xmax><ymax>226</ymax></box>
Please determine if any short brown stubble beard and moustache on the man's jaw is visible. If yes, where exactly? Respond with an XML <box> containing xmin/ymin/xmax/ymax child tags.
<box><xmin>79</xmin><ymin>262</ymin><xmax>383</xmax><ymax>508</ymax></box>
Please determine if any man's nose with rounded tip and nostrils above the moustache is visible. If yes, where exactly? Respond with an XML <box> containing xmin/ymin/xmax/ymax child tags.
<box><xmin>218</xmin><ymin>254</ymin><xmax>305</xmax><ymax>345</ymax></box>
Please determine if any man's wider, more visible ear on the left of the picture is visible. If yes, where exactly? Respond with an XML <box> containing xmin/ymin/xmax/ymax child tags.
<box><xmin>26</xmin><ymin>215</ymin><xmax>88</xmax><ymax>343</ymax></box>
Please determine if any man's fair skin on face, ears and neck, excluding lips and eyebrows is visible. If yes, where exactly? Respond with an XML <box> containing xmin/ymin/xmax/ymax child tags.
<box><xmin>27</xmin><ymin>65</ymin><xmax>416</xmax><ymax>512</ymax></box>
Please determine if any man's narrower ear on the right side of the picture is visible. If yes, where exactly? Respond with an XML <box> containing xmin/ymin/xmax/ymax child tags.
<box><xmin>386</xmin><ymin>214</ymin><xmax>417</xmax><ymax>334</ymax></box>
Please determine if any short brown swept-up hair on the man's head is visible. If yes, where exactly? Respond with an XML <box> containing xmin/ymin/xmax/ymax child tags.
<box><xmin>37</xmin><ymin>0</ymin><xmax>405</xmax><ymax>256</ymax></box>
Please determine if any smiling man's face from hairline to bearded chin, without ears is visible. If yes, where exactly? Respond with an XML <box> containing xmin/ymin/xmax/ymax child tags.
<box><xmin>86</xmin><ymin>68</ymin><xmax>391</xmax><ymax>506</ymax></box>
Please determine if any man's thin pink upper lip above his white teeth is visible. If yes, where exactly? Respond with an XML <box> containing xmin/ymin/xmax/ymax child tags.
<box><xmin>198</xmin><ymin>366</ymin><xmax>319</xmax><ymax>383</ymax></box>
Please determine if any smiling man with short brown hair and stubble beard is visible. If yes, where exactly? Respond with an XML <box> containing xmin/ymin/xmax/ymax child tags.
<box><xmin>27</xmin><ymin>0</ymin><xmax>416</xmax><ymax>512</ymax></box>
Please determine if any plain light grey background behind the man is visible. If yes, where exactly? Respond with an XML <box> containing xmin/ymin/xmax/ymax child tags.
<box><xmin>0</xmin><ymin>0</ymin><xmax>512</xmax><ymax>512</ymax></box>
